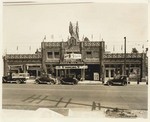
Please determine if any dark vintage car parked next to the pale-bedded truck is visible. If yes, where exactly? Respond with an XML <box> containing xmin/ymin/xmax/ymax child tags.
<box><xmin>35</xmin><ymin>75</ymin><xmax>56</xmax><ymax>84</ymax></box>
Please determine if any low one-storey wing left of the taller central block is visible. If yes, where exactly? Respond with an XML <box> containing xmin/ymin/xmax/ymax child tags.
<box><xmin>3</xmin><ymin>52</ymin><xmax>42</xmax><ymax>78</ymax></box>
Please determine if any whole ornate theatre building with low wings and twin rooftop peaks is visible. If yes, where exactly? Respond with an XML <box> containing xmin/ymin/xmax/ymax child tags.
<box><xmin>3</xmin><ymin>22</ymin><xmax>148</xmax><ymax>82</ymax></box>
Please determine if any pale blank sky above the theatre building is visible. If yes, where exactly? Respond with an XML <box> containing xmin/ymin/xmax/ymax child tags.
<box><xmin>2</xmin><ymin>1</ymin><xmax>148</xmax><ymax>55</ymax></box>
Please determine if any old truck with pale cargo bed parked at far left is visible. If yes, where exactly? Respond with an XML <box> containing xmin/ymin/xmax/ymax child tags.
<box><xmin>2</xmin><ymin>73</ymin><xmax>29</xmax><ymax>84</ymax></box>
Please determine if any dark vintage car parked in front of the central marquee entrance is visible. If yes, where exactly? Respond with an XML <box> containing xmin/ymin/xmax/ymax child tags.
<box><xmin>60</xmin><ymin>75</ymin><xmax>79</xmax><ymax>85</ymax></box>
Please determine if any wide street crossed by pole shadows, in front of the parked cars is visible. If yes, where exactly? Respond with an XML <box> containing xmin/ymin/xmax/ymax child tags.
<box><xmin>2</xmin><ymin>84</ymin><xmax>148</xmax><ymax>110</ymax></box>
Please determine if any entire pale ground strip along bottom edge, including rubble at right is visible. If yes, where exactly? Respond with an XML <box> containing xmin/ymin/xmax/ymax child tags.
<box><xmin>1</xmin><ymin>108</ymin><xmax>148</xmax><ymax>118</ymax></box>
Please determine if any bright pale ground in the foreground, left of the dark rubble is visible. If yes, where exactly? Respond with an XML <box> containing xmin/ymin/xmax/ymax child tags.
<box><xmin>1</xmin><ymin>108</ymin><xmax>105</xmax><ymax>119</ymax></box>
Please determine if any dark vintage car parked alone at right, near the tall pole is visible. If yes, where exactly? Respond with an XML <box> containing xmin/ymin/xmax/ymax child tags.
<box><xmin>106</xmin><ymin>75</ymin><xmax>128</xmax><ymax>86</ymax></box>
